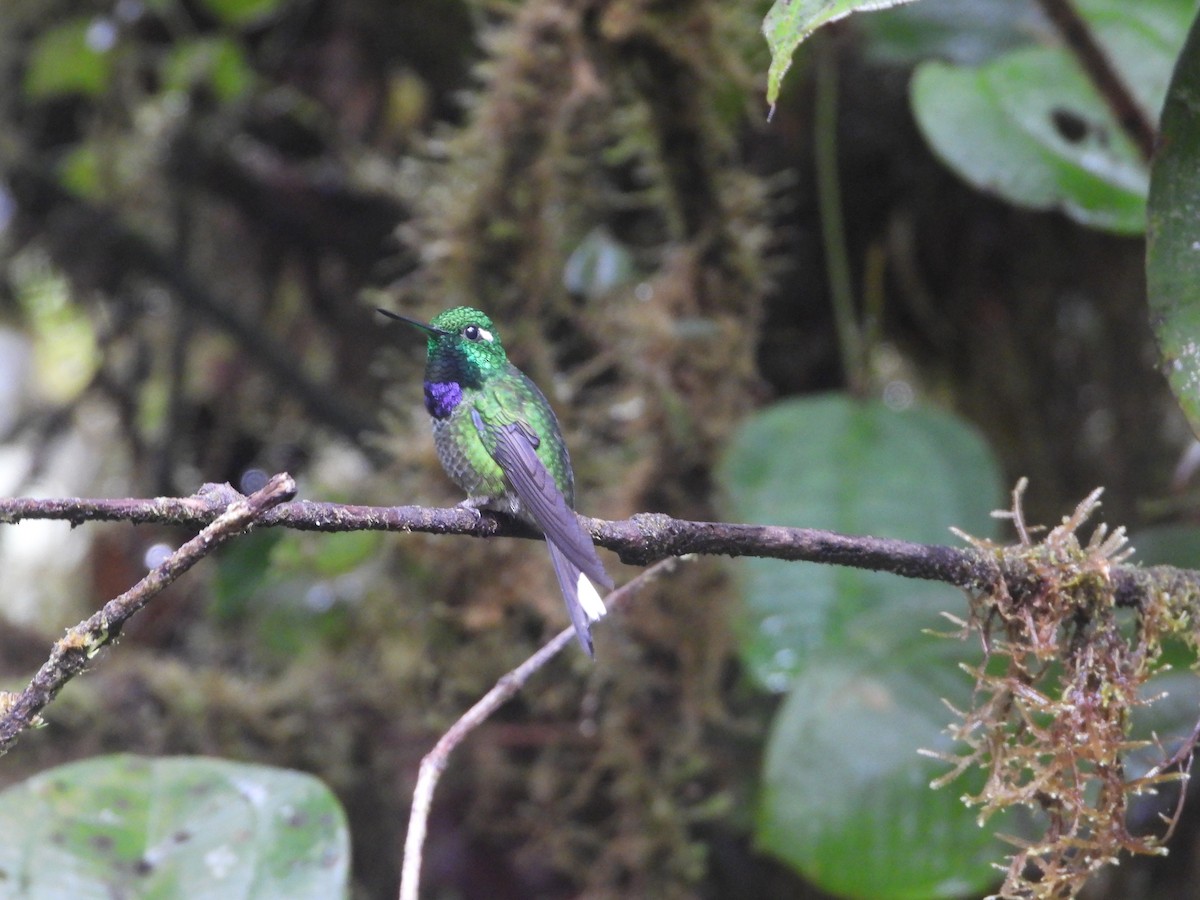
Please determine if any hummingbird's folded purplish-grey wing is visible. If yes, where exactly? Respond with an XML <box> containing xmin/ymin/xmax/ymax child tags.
<box><xmin>470</xmin><ymin>409</ymin><xmax>612</xmax><ymax>595</ymax></box>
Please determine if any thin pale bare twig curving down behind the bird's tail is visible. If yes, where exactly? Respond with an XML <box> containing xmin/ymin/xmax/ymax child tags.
<box><xmin>400</xmin><ymin>558</ymin><xmax>680</xmax><ymax>900</ymax></box>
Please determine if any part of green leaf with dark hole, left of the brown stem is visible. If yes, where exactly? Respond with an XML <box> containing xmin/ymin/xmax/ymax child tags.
<box><xmin>911</xmin><ymin>47</ymin><xmax>1147</xmax><ymax>234</ymax></box>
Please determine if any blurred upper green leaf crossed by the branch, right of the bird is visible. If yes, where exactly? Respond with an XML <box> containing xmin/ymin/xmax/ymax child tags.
<box><xmin>718</xmin><ymin>395</ymin><xmax>1001</xmax><ymax>690</ymax></box>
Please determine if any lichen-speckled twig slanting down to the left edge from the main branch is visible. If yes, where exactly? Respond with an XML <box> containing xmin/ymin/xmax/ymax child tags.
<box><xmin>0</xmin><ymin>473</ymin><xmax>296</xmax><ymax>755</ymax></box>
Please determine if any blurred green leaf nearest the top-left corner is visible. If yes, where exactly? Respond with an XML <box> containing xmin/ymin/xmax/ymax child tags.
<box><xmin>25</xmin><ymin>16</ymin><xmax>113</xmax><ymax>100</ymax></box>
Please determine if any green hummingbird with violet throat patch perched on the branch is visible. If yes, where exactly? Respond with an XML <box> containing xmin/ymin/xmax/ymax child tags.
<box><xmin>379</xmin><ymin>306</ymin><xmax>612</xmax><ymax>656</ymax></box>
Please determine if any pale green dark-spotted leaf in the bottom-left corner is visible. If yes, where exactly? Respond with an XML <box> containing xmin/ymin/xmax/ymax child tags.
<box><xmin>0</xmin><ymin>755</ymin><xmax>350</xmax><ymax>900</ymax></box>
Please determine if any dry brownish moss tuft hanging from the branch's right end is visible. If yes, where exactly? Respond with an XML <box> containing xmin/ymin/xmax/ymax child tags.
<box><xmin>934</xmin><ymin>479</ymin><xmax>1187</xmax><ymax>898</ymax></box>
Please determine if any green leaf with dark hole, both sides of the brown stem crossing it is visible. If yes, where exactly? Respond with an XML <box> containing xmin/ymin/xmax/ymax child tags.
<box><xmin>912</xmin><ymin>0</ymin><xmax>1195</xmax><ymax>234</ymax></box>
